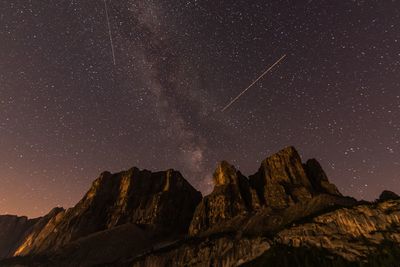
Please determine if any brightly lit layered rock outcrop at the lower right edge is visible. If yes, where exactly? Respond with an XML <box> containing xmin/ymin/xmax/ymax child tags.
<box><xmin>275</xmin><ymin>200</ymin><xmax>400</xmax><ymax>261</ymax></box>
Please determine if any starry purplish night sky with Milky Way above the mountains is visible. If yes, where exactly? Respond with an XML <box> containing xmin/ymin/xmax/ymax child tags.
<box><xmin>0</xmin><ymin>0</ymin><xmax>400</xmax><ymax>217</ymax></box>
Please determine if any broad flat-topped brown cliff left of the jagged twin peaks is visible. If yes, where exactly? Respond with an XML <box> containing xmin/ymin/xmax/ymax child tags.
<box><xmin>14</xmin><ymin>168</ymin><xmax>201</xmax><ymax>256</ymax></box>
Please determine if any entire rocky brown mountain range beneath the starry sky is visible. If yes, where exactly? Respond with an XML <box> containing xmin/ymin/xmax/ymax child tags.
<box><xmin>0</xmin><ymin>147</ymin><xmax>400</xmax><ymax>266</ymax></box>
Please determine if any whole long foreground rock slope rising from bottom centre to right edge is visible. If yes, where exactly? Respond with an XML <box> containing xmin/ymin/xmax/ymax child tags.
<box><xmin>123</xmin><ymin>200</ymin><xmax>400</xmax><ymax>267</ymax></box>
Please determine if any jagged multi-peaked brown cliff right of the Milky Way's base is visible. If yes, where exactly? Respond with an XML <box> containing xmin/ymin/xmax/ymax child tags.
<box><xmin>189</xmin><ymin>147</ymin><xmax>341</xmax><ymax>235</ymax></box>
